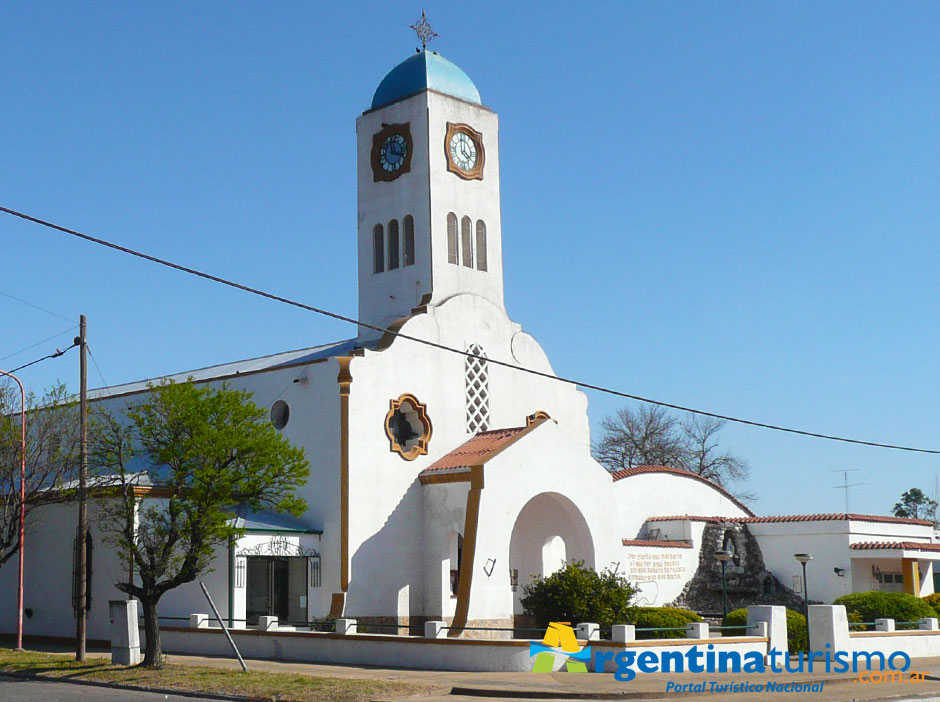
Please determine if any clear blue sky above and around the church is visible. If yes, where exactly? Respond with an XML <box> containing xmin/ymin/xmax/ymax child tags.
<box><xmin>0</xmin><ymin>1</ymin><xmax>940</xmax><ymax>514</ymax></box>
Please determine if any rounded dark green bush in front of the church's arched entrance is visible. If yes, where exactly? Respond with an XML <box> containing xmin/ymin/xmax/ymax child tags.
<box><xmin>522</xmin><ymin>561</ymin><xmax>636</xmax><ymax>627</ymax></box>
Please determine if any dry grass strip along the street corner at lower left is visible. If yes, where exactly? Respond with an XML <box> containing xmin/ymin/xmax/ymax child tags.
<box><xmin>0</xmin><ymin>648</ymin><xmax>431</xmax><ymax>702</ymax></box>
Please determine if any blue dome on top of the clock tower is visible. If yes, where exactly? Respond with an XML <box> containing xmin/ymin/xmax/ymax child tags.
<box><xmin>372</xmin><ymin>51</ymin><xmax>483</xmax><ymax>110</ymax></box>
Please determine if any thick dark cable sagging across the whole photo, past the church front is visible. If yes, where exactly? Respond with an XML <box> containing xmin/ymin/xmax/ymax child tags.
<box><xmin>0</xmin><ymin>206</ymin><xmax>940</xmax><ymax>455</ymax></box>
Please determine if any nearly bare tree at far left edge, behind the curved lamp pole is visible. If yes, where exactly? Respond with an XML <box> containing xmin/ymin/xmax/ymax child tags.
<box><xmin>0</xmin><ymin>383</ymin><xmax>79</xmax><ymax>567</ymax></box>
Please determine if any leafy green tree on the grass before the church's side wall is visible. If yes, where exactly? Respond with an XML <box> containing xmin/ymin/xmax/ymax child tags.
<box><xmin>91</xmin><ymin>382</ymin><xmax>309</xmax><ymax>667</ymax></box>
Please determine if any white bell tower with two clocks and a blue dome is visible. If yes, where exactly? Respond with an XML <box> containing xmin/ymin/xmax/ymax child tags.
<box><xmin>356</xmin><ymin>42</ymin><xmax>504</xmax><ymax>338</ymax></box>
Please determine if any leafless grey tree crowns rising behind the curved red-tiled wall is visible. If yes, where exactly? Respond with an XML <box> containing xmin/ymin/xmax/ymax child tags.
<box><xmin>593</xmin><ymin>405</ymin><xmax>755</xmax><ymax>500</ymax></box>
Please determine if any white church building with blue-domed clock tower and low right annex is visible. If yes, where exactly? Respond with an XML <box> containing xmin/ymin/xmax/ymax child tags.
<box><xmin>0</xmin><ymin>50</ymin><xmax>938</xmax><ymax>639</ymax></box>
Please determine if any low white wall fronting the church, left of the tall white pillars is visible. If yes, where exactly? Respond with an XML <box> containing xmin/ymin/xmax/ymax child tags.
<box><xmin>158</xmin><ymin>627</ymin><xmax>767</xmax><ymax>672</ymax></box>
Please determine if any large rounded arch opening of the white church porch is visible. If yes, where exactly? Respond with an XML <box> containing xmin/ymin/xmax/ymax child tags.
<box><xmin>509</xmin><ymin>492</ymin><xmax>595</xmax><ymax>614</ymax></box>
